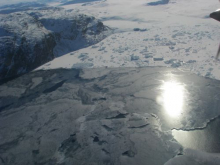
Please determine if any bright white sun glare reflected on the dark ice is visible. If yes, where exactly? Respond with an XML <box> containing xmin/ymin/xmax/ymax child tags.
<box><xmin>161</xmin><ymin>81</ymin><xmax>184</xmax><ymax>117</ymax></box>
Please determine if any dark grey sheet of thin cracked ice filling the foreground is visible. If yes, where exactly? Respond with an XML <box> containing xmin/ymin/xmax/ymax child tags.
<box><xmin>0</xmin><ymin>67</ymin><xmax>220</xmax><ymax>165</ymax></box>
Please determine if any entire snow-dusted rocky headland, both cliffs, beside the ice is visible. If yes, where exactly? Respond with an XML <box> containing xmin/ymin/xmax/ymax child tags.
<box><xmin>0</xmin><ymin>8</ymin><xmax>110</xmax><ymax>79</ymax></box>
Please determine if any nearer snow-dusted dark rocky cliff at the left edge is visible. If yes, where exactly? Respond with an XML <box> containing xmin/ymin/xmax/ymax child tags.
<box><xmin>0</xmin><ymin>12</ymin><xmax>56</xmax><ymax>79</ymax></box>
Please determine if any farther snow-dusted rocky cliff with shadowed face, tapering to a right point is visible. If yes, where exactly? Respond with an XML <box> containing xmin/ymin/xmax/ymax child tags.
<box><xmin>28</xmin><ymin>8</ymin><xmax>111</xmax><ymax>57</ymax></box>
